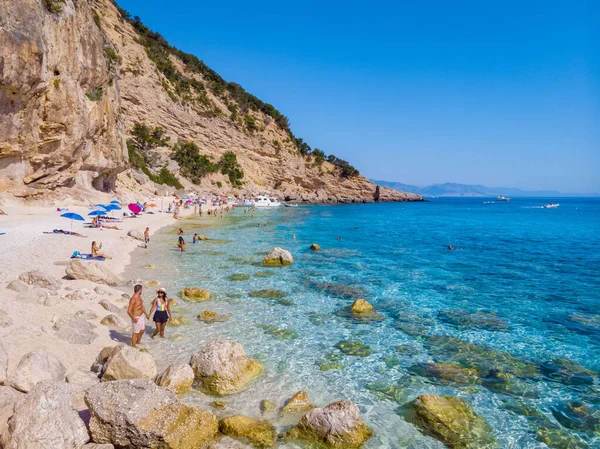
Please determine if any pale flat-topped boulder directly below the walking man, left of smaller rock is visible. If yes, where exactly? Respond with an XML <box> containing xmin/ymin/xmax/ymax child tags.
<box><xmin>102</xmin><ymin>344</ymin><xmax>156</xmax><ymax>382</ymax></box>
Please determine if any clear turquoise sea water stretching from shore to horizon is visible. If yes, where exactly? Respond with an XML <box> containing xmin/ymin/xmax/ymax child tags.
<box><xmin>129</xmin><ymin>199</ymin><xmax>600</xmax><ymax>449</ymax></box>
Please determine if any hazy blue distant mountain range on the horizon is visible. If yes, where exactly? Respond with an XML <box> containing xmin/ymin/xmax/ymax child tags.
<box><xmin>371</xmin><ymin>179</ymin><xmax>595</xmax><ymax>197</ymax></box>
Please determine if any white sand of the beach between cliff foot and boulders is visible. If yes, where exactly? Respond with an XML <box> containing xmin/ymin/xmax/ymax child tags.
<box><xmin>0</xmin><ymin>201</ymin><xmax>211</xmax><ymax>384</ymax></box>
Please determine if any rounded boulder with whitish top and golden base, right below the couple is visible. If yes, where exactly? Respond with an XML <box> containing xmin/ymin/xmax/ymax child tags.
<box><xmin>190</xmin><ymin>340</ymin><xmax>264</xmax><ymax>396</ymax></box>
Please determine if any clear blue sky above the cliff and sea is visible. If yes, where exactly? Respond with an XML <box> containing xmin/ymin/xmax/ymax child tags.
<box><xmin>118</xmin><ymin>0</ymin><xmax>600</xmax><ymax>193</ymax></box>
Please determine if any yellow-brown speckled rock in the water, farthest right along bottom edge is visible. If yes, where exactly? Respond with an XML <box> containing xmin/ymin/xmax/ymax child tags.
<box><xmin>409</xmin><ymin>395</ymin><xmax>494</xmax><ymax>449</ymax></box>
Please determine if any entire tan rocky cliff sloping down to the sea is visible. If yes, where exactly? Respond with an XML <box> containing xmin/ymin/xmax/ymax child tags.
<box><xmin>0</xmin><ymin>0</ymin><xmax>420</xmax><ymax>202</ymax></box>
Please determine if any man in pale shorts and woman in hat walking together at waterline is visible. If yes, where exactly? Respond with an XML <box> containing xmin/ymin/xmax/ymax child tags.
<box><xmin>127</xmin><ymin>284</ymin><xmax>172</xmax><ymax>348</ymax></box>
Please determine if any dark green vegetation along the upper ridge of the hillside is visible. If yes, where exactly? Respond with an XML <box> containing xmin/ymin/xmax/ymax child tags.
<box><xmin>109</xmin><ymin>0</ymin><xmax>360</xmax><ymax>178</ymax></box>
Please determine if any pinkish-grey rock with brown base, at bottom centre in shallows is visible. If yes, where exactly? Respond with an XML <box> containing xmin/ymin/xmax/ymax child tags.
<box><xmin>285</xmin><ymin>401</ymin><xmax>373</xmax><ymax>448</ymax></box>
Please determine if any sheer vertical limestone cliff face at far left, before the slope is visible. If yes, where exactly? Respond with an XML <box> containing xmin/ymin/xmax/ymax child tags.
<box><xmin>0</xmin><ymin>0</ymin><xmax>128</xmax><ymax>198</ymax></box>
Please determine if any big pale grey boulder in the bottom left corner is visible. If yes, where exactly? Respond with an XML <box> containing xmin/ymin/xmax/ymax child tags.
<box><xmin>2</xmin><ymin>382</ymin><xmax>89</xmax><ymax>449</ymax></box>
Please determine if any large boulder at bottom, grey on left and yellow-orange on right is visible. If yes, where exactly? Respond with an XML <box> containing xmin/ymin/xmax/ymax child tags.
<box><xmin>85</xmin><ymin>379</ymin><xmax>218</xmax><ymax>449</ymax></box>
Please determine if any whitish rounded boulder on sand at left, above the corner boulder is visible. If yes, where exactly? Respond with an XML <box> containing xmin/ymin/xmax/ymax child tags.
<box><xmin>8</xmin><ymin>350</ymin><xmax>67</xmax><ymax>393</ymax></box>
